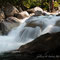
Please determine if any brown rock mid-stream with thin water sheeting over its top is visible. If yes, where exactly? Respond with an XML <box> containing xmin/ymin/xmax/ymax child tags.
<box><xmin>26</xmin><ymin>16</ymin><xmax>46</xmax><ymax>29</ymax></box>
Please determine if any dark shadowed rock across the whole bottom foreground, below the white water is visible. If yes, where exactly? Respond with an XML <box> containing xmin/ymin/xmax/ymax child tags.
<box><xmin>0</xmin><ymin>32</ymin><xmax>60</xmax><ymax>60</ymax></box>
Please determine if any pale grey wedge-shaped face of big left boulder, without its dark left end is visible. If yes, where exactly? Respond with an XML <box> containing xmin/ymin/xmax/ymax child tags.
<box><xmin>3</xmin><ymin>21</ymin><xmax>20</xmax><ymax>34</ymax></box>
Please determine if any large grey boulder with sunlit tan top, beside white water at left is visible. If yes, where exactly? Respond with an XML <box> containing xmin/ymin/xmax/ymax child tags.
<box><xmin>0</xmin><ymin>17</ymin><xmax>20</xmax><ymax>35</ymax></box>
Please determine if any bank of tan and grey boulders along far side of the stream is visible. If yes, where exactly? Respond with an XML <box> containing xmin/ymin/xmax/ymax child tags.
<box><xmin>0</xmin><ymin>4</ymin><xmax>60</xmax><ymax>35</ymax></box>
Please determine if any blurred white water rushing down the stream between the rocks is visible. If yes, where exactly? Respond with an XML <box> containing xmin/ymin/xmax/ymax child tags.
<box><xmin>0</xmin><ymin>16</ymin><xmax>60</xmax><ymax>52</ymax></box>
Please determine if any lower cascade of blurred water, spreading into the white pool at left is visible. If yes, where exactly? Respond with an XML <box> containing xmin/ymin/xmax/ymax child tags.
<box><xmin>0</xmin><ymin>17</ymin><xmax>40</xmax><ymax>53</ymax></box>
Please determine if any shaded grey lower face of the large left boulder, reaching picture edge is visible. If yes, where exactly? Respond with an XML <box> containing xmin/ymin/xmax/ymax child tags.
<box><xmin>0</xmin><ymin>21</ymin><xmax>20</xmax><ymax>35</ymax></box>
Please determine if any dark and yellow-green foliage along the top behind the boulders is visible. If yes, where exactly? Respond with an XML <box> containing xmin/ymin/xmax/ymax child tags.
<box><xmin>0</xmin><ymin>0</ymin><xmax>60</xmax><ymax>10</ymax></box>
